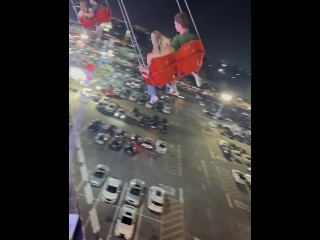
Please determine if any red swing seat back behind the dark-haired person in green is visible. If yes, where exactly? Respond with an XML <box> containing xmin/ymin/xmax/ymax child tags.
<box><xmin>175</xmin><ymin>40</ymin><xmax>205</xmax><ymax>79</ymax></box>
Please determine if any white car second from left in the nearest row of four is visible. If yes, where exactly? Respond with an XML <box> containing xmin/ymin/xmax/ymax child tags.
<box><xmin>101</xmin><ymin>177</ymin><xmax>122</xmax><ymax>204</ymax></box>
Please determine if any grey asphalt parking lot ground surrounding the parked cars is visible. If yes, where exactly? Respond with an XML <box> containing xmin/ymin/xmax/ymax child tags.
<box><xmin>70</xmin><ymin>85</ymin><xmax>251</xmax><ymax>239</ymax></box>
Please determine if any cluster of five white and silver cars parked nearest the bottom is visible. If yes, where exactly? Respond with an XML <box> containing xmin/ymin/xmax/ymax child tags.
<box><xmin>90</xmin><ymin>164</ymin><xmax>166</xmax><ymax>239</ymax></box>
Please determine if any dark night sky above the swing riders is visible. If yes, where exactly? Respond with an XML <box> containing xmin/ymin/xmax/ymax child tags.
<box><xmin>69</xmin><ymin>0</ymin><xmax>251</xmax><ymax>72</ymax></box>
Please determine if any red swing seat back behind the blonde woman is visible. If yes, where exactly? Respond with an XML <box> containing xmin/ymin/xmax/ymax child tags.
<box><xmin>144</xmin><ymin>53</ymin><xmax>177</xmax><ymax>88</ymax></box>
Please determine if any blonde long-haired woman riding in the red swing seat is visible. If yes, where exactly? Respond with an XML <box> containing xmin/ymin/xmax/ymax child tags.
<box><xmin>139</xmin><ymin>31</ymin><xmax>179</xmax><ymax>104</ymax></box>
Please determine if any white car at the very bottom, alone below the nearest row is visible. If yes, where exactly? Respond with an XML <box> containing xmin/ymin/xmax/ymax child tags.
<box><xmin>114</xmin><ymin>204</ymin><xmax>137</xmax><ymax>240</ymax></box>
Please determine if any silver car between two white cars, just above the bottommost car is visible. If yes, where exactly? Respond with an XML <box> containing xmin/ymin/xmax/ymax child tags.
<box><xmin>125</xmin><ymin>179</ymin><xmax>145</xmax><ymax>206</ymax></box>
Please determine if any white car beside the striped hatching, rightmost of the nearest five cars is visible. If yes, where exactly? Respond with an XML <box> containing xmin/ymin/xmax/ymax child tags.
<box><xmin>148</xmin><ymin>186</ymin><xmax>166</xmax><ymax>213</ymax></box>
